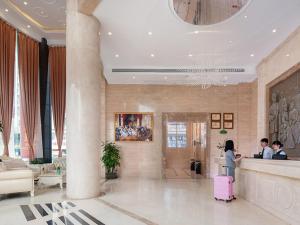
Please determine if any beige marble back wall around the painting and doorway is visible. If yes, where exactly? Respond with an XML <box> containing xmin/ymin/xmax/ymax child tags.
<box><xmin>106</xmin><ymin>83</ymin><xmax>256</xmax><ymax>178</ymax></box>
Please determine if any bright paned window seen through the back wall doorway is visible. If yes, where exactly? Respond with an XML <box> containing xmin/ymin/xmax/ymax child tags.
<box><xmin>167</xmin><ymin>122</ymin><xmax>187</xmax><ymax>148</ymax></box>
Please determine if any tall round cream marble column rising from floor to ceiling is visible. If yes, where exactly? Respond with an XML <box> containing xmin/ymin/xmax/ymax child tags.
<box><xmin>66</xmin><ymin>0</ymin><xmax>101</xmax><ymax>199</ymax></box>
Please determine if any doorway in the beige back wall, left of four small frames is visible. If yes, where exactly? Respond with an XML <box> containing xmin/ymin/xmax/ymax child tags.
<box><xmin>162</xmin><ymin>113</ymin><xmax>209</xmax><ymax>179</ymax></box>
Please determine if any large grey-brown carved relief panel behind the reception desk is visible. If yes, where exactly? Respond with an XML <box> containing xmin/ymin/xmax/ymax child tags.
<box><xmin>268</xmin><ymin>70</ymin><xmax>300</xmax><ymax>157</ymax></box>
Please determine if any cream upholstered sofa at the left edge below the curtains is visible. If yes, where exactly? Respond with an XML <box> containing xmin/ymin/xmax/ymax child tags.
<box><xmin>0</xmin><ymin>162</ymin><xmax>34</xmax><ymax>196</ymax></box>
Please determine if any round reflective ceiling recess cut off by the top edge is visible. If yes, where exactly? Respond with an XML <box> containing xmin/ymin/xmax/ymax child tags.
<box><xmin>170</xmin><ymin>0</ymin><xmax>250</xmax><ymax>25</ymax></box>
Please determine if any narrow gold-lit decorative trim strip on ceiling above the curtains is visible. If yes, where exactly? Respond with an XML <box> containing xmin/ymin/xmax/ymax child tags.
<box><xmin>4</xmin><ymin>0</ymin><xmax>66</xmax><ymax>33</ymax></box>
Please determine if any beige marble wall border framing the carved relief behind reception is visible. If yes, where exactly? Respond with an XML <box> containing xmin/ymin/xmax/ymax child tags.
<box><xmin>257</xmin><ymin>27</ymin><xmax>300</xmax><ymax>138</ymax></box>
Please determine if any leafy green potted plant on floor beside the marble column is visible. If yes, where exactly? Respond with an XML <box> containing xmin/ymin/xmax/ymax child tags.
<box><xmin>101</xmin><ymin>142</ymin><xmax>121</xmax><ymax>179</ymax></box>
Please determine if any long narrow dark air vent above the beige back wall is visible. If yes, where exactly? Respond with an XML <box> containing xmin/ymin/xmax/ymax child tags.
<box><xmin>112</xmin><ymin>68</ymin><xmax>245</xmax><ymax>73</ymax></box>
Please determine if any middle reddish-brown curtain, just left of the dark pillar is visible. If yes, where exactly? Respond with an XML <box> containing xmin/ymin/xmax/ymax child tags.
<box><xmin>18</xmin><ymin>33</ymin><xmax>39</xmax><ymax>160</ymax></box>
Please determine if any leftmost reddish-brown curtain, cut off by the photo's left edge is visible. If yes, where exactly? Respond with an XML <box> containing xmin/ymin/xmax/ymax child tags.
<box><xmin>0</xmin><ymin>20</ymin><xmax>16</xmax><ymax>156</ymax></box>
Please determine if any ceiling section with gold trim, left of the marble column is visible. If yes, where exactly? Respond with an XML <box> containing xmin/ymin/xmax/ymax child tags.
<box><xmin>0</xmin><ymin>0</ymin><xmax>66</xmax><ymax>44</ymax></box>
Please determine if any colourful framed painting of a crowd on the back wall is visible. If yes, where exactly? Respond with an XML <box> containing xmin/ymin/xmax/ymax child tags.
<box><xmin>115</xmin><ymin>113</ymin><xmax>153</xmax><ymax>141</ymax></box>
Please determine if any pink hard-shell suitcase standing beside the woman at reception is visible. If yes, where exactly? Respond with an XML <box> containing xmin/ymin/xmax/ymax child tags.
<box><xmin>214</xmin><ymin>176</ymin><xmax>233</xmax><ymax>202</ymax></box>
